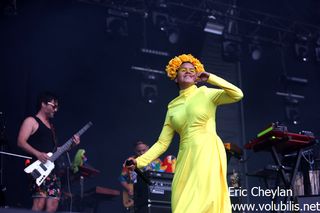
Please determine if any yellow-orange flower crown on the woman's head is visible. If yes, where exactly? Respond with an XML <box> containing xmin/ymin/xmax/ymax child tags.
<box><xmin>166</xmin><ymin>54</ymin><xmax>204</xmax><ymax>80</ymax></box>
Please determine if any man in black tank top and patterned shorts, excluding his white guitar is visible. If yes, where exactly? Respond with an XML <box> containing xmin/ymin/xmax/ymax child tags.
<box><xmin>18</xmin><ymin>92</ymin><xmax>80</xmax><ymax>213</ymax></box>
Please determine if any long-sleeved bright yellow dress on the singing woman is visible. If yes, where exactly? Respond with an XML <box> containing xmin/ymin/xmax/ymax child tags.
<box><xmin>136</xmin><ymin>74</ymin><xmax>243</xmax><ymax>213</ymax></box>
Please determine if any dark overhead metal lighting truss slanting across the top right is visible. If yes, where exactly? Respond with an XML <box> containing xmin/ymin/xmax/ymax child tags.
<box><xmin>78</xmin><ymin>0</ymin><xmax>320</xmax><ymax>45</ymax></box>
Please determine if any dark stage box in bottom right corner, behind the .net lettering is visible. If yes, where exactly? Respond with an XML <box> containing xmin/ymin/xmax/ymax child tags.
<box><xmin>297</xmin><ymin>196</ymin><xmax>320</xmax><ymax>213</ymax></box>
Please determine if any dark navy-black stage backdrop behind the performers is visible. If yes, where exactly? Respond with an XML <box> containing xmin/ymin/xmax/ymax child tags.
<box><xmin>0</xmin><ymin>0</ymin><xmax>320</xmax><ymax>212</ymax></box>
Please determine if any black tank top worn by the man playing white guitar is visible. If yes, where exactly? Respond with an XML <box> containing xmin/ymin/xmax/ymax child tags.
<box><xmin>28</xmin><ymin>117</ymin><xmax>56</xmax><ymax>155</ymax></box>
